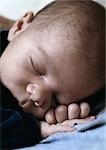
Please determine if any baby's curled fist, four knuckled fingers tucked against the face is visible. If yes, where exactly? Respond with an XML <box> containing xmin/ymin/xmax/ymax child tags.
<box><xmin>45</xmin><ymin>102</ymin><xmax>90</xmax><ymax>124</ymax></box>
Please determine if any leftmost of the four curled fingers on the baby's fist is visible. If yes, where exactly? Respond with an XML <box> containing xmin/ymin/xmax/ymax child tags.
<box><xmin>45</xmin><ymin>107</ymin><xmax>56</xmax><ymax>124</ymax></box>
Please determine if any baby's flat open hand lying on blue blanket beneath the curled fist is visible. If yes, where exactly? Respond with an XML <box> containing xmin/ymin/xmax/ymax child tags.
<box><xmin>41</xmin><ymin>116</ymin><xmax>95</xmax><ymax>138</ymax></box>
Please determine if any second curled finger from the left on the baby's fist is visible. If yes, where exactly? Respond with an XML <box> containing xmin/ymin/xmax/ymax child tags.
<box><xmin>55</xmin><ymin>105</ymin><xmax>68</xmax><ymax>123</ymax></box>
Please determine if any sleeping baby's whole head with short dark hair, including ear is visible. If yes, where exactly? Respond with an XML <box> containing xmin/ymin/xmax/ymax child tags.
<box><xmin>0</xmin><ymin>1</ymin><xmax>105</xmax><ymax>118</ymax></box>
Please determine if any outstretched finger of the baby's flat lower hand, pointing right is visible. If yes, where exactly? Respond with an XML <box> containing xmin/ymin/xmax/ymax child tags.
<box><xmin>62</xmin><ymin>116</ymin><xmax>95</xmax><ymax>127</ymax></box>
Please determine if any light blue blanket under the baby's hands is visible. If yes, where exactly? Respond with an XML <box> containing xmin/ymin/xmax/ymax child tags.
<box><xmin>20</xmin><ymin>111</ymin><xmax>106</xmax><ymax>150</ymax></box>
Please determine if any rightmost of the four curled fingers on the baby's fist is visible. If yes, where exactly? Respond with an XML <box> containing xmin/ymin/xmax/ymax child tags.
<box><xmin>80</xmin><ymin>102</ymin><xmax>90</xmax><ymax>118</ymax></box>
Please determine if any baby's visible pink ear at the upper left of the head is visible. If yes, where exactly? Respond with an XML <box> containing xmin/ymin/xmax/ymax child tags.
<box><xmin>8</xmin><ymin>12</ymin><xmax>34</xmax><ymax>41</ymax></box>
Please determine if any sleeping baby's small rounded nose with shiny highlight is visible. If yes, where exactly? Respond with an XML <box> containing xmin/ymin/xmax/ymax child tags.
<box><xmin>26</xmin><ymin>84</ymin><xmax>45</xmax><ymax>106</ymax></box>
